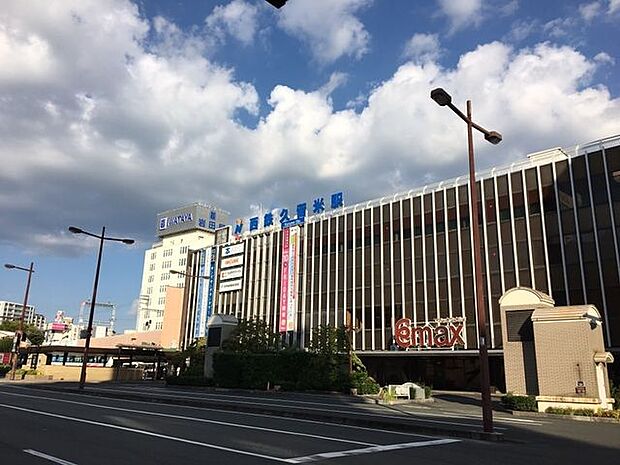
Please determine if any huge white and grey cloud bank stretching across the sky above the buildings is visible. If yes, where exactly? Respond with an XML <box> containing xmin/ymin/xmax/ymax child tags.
<box><xmin>0</xmin><ymin>0</ymin><xmax>620</xmax><ymax>254</ymax></box>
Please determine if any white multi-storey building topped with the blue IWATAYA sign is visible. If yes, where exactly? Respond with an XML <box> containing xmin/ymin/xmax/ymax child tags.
<box><xmin>136</xmin><ymin>203</ymin><xmax>229</xmax><ymax>331</ymax></box>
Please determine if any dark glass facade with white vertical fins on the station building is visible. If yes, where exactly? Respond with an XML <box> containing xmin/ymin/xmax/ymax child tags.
<box><xmin>197</xmin><ymin>138</ymin><xmax>620</xmax><ymax>352</ymax></box>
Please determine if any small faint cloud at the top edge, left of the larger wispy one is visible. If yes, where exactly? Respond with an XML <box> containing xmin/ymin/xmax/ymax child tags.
<box><xmin>205</xmin><ymin>0</ymin><xmax>258</xmax><ymax>45</ymax></box>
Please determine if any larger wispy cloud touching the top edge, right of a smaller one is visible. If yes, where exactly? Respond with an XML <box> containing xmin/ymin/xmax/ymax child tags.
<box><xmin>278</xmin><ymin>0</ymin><xmax>372</xmax><ymax>64</ymax></box>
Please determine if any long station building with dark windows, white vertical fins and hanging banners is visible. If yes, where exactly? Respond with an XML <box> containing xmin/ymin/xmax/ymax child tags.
<box><xmin>171</xmin><ymin>136</ymin><xmax>620</xmax><ymax>389</ymax></box>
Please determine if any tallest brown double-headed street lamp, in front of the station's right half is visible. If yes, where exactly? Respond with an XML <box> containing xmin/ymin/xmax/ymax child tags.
<box><xmin>431</xmin><ymin>87</ymin><xmax>502</xmax><ymax>433</ymax></box>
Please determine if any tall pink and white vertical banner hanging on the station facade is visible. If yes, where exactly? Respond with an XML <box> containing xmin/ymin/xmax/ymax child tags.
<box><xmin>280</xmin><ymin>226</ymin><xmax>300</xmax><ymax>333</ymax></box>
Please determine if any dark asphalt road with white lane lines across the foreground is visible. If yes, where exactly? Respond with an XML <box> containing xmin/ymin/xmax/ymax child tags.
<box><xmin>0</xmin><ymin>384</ymin><xmax>620</xmax><ymax>465</ymax></box>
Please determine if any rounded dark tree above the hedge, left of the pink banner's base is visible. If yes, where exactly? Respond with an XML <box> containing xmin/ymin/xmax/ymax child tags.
<box><xmin>222</xmin><ymin>319</ymin><xmax>281</xmax><ymax>354</ymax></box>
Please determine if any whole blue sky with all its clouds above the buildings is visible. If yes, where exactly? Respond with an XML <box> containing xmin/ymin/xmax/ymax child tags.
<box><xmin>0</xmin><ymin>0</ymin><xmax>620</xmax><ymax>330</ymax></box>
